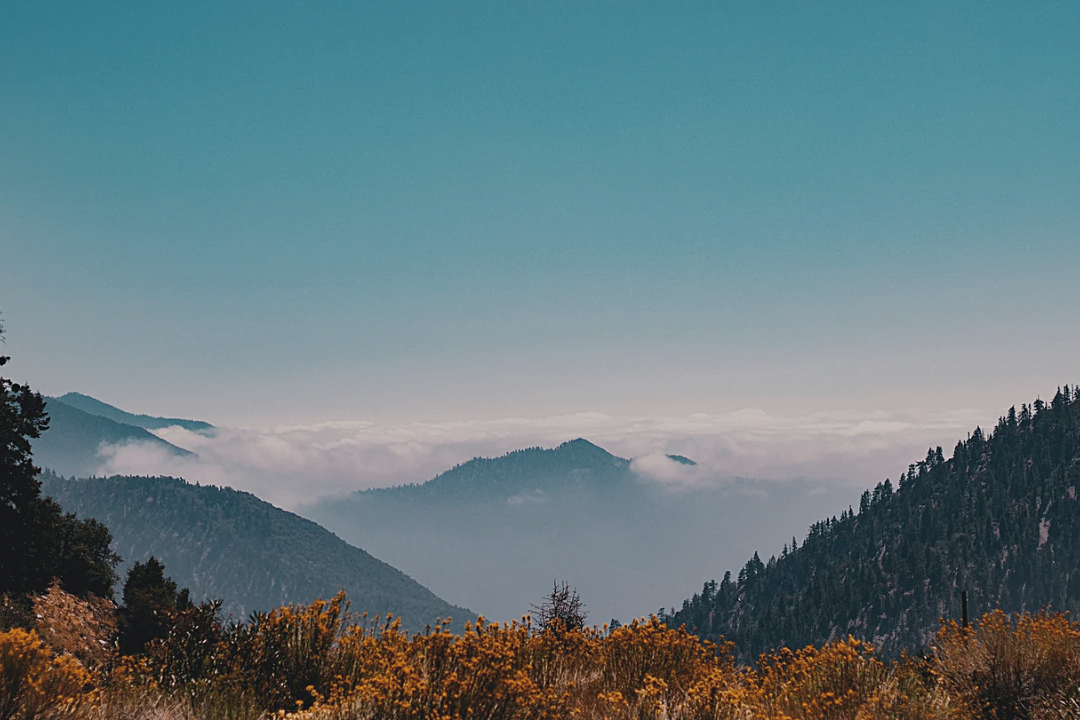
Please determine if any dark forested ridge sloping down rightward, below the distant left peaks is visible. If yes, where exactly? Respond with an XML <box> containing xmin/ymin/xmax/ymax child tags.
<box><xmin>42</xmin><ymin>474</ymin><xmax>472</xmax><ymax>630</ymax></box>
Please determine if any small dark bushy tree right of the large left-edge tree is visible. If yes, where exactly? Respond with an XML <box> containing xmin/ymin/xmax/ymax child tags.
<box><xmin>117</xmin><ymin>557</ymin><xmax>193</xmax><ymax>655</ymax></box>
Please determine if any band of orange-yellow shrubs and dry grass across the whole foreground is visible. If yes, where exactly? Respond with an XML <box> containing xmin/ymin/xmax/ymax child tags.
<box><xmin>0</xmin><ymin>595</ymin><xmax>1080</xmax><ymax>720</ymax></box>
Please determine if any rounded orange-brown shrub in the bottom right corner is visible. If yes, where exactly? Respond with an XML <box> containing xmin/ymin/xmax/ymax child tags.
<box><xmin>935</xmin><ymin>610</ymin><xmax>1080</xmax><ymax>720</ymax></box>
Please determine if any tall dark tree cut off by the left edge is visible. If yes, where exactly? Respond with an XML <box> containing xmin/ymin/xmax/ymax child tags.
<box><xmin>0</xmin><ymin>317</ymin><xmax>119</xmax><ymax>596</ymax></box>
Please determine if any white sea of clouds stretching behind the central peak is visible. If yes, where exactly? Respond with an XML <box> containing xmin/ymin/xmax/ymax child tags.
<box><xmin>98</xmin><ymin>409</ymin><xmax>990</xmax><ymax>508</ymax></box>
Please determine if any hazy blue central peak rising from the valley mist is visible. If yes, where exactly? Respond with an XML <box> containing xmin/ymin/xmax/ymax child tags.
<box><xmin>299</xmin><ymin>439</ymin><xmax>856</xmax><ymax>623</ymax></box>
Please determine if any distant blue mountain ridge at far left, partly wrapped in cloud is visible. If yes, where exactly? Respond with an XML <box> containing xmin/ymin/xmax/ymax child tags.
<box><xmin>32</xmin><ymin>397</ymin><xmax>191</xmax><ymax>476</ymax></box>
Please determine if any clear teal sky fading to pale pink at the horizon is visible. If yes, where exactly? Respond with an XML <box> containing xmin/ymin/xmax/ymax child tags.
<box><xmin>0</xmin><ymin>1</ymin><xmax>1080</xmax><ymax>422</ymax></box>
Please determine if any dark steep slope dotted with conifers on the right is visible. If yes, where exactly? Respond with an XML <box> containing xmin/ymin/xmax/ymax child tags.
<box><xmin>667</xmin><ymin>386</ymin><xmax>1080</xmax><ymax>660</ymax></box>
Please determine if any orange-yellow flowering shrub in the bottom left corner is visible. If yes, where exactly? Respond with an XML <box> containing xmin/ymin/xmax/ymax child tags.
<box><xmin>0</xmin><ymin>628</ymin><xmax>94</xmax><ymax>720</ymax></box>
